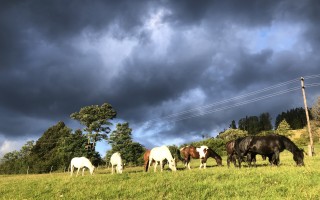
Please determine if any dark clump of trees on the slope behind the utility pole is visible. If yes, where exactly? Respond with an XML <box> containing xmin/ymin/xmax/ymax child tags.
<box><xmin>275</xmin><ymin>107</ymin><xmax>313</xmax><ymax>130</ymax></box>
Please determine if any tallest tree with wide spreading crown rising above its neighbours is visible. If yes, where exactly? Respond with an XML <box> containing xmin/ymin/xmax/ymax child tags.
<box><xmin>70</xmin><ymin>103</ymin><xmax>117</xmax><ymax>150</ymax></box>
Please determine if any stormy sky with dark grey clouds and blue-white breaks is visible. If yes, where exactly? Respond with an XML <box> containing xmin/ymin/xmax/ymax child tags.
<box><xmin>0</xmin><ymin>0</ymin><xmax>320</xmax><ymax>156</ymax></box>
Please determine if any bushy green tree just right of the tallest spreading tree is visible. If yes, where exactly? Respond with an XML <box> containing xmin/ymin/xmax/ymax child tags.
<box><xmin>106</xmin><ymin>123</ymin><xmax>145</xmax><ymax>165</ymax></box>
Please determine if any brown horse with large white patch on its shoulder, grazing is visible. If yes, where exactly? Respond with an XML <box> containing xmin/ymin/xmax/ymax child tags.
<box><xmin>180</xmin><ymin>146</ymin><xmax>222</xmax><ymax>169</ymax></box>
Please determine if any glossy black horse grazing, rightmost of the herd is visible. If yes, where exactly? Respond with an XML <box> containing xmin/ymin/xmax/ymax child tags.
<box><xmin>246</xmin><ymin>134</ymin><xmax>304</xmax><ymax>166</ymax></box>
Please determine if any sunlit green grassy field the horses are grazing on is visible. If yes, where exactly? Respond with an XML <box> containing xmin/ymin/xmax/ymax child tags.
<box><xmin>0</xmin><ymin>149</ymin><xmax>320</xmax><ymax>199</ymax></box>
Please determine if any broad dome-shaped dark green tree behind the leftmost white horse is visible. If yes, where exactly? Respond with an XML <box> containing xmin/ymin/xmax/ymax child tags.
<box><xmin>28</xmin><ymin>122</ymin><xmax>103</xmax><ymax>173</ymax></box>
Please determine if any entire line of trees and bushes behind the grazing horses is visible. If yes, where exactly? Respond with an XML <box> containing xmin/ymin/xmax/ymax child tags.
<box><xmin>0</xmin><ymin>98</ymin><xmax>320</xmax><ymax>174</ymax></box>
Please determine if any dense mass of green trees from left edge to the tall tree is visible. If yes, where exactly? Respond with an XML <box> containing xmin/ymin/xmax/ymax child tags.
<box><xmin>0</xmin><ymin>122</ymin><xmax>102</xmax><ymax>174</ymax></box>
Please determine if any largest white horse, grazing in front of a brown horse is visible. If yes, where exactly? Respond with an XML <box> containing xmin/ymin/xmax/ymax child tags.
<box><xmin>148</xmin><ymin>146</ymin><xmax>177</xmax><ymax>172</ymax></box>
